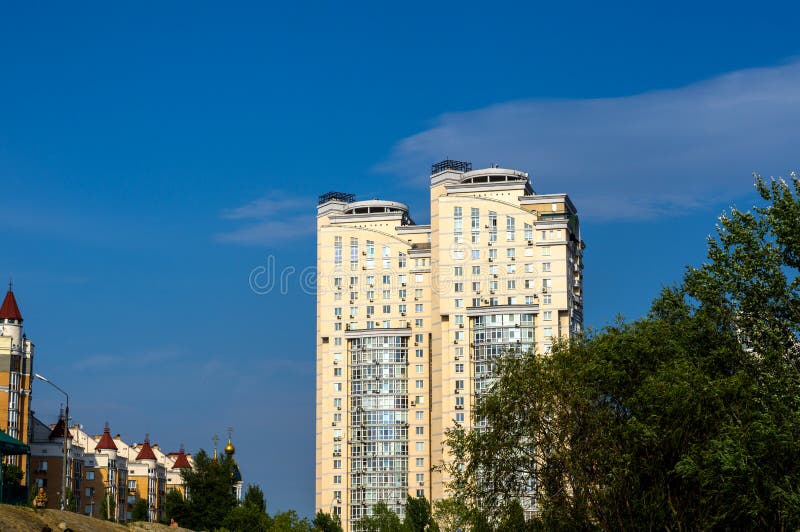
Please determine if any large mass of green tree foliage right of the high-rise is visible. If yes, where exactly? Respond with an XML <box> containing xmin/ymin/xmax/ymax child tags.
<box><xmin>436</xmin><ymin>174</ymin><xmax>800</xmax><ymax>530</ymax></box>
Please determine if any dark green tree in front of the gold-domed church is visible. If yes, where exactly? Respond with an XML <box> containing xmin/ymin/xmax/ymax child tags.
<box><xmin>183</xmin><ymin>449</ymin><xmax>236</xmax><ymax>530</ymax></box>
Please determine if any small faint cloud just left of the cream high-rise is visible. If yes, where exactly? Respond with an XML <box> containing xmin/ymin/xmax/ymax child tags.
<box><xmin>215</xmin><ymin>193</ymin><xmax>316</xmax><ymax>246</ymax></box>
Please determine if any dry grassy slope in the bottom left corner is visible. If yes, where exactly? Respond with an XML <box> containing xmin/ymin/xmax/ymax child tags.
<box><xmin>0</xmin><ymin>504</ymin><xmax>191</xmax><ymax>532</ymax></box>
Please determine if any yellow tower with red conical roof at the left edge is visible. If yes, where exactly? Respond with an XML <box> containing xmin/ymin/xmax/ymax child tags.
<box><xmin>0</xmin><ymin>283</ymin><xmax>34</xmax><ymax>471</ymax></box>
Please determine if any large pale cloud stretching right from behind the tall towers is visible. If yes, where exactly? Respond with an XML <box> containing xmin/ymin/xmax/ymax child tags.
<box><xmin>380</xmin><ymin>61</ymin><xmax>800</xmax><ymax>219</ymax></box>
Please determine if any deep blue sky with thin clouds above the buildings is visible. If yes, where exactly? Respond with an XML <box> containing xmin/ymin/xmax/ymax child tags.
<box><xmin>0</xmin><ymin>2</ymin><xmax>800</xmax><ymax>515</ymax></box>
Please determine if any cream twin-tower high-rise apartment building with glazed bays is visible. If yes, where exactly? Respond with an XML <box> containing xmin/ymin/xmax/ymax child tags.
<box><xmin>316</xmin><ymin>160</ymin><xmax>583</xmax><ymax>530</ymax></box>
